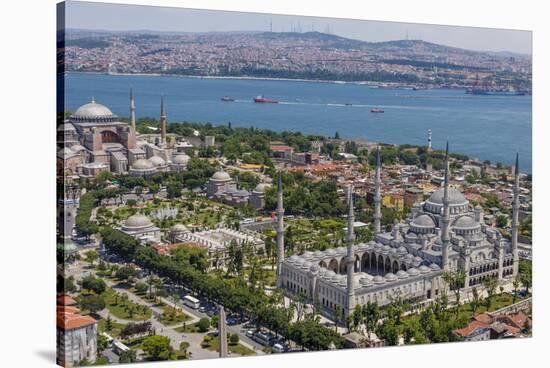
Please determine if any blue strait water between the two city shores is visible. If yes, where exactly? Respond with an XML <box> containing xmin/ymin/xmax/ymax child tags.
<box><xmin>65</xmin><ymin>73</ymin><xmax>532</xmax><ymax>173</ymax></box>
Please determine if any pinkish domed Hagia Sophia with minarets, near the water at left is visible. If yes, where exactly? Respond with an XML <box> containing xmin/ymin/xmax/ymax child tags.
<box><xmin>57</xmin><ymin>92</ymin><xmax>189</xmax><ymax>177</ymax></box>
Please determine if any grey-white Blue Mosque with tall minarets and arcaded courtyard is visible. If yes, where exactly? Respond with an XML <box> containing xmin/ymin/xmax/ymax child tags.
<box><xmin>277</xmin><ymin>146</ymin><xmax>519</xmax><ymax>317</ymax></box>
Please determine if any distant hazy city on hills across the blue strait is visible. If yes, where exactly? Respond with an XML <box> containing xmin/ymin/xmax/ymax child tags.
<box><xmin>64</xmin><ymin>29</ymin><xmax>531</xmax><ymax>93</ymax></box>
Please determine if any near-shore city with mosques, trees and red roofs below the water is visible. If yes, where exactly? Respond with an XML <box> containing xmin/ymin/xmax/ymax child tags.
<box><xmin>57</xmin><ymin>92</ymin><xmax>532</xmax><ymax>366</ymax></box>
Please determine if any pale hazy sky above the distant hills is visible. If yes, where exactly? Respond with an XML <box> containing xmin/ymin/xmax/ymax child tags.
<box><xmin>66</xmin><ymin>1</ymin><xmax>532</xmax><ymax>54</ymax></box>
